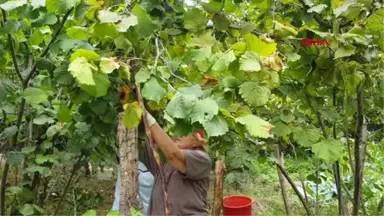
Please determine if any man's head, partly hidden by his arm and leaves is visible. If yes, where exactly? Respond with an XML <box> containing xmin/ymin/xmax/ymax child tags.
<box><xmin>173</xmin><ymin>130</ymin><xmax>207</xmax><ymax>151</ymax></box>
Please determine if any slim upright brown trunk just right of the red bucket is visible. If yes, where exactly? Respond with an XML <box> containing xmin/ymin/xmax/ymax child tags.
<box><xmin>275</xmin><ymin>141</ymin><xmax>292</xmax><ymax>216</ymax></box>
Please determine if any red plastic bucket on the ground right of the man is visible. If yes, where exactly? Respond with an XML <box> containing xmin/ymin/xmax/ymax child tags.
<box><xmin>223</xmin><ymin>196</ymin><xmax>253</xmax><ymax>216</ymax></box>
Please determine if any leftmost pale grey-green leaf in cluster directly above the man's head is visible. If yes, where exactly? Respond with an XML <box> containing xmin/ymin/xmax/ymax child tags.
<box><xmin>166</xmin><ymin>93</ymin><xmax>196</xmax><ymax>119</ymax></box>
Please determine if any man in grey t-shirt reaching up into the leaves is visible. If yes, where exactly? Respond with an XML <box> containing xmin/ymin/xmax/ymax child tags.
<box><xmin>146</xmin><ymin>113</ymin><xmax>211</xmax><ymax>216</ymax></box>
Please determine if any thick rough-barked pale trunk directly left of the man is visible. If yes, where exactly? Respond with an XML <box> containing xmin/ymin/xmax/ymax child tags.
<box><xmin>117</xmin><ymin>113</ymin><xmax>142</xmax><ymax>216</ymax></box>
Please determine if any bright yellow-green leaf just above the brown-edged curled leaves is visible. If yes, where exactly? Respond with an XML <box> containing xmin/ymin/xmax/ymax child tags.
<box><xmin>243</xmin><ymin>34</ymin><xmax>277</xmax><ymax>56</ymax></box>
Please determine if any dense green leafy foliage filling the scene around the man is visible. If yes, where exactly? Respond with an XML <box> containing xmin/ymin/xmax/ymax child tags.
<box><xmin>0</xmin><ymin>0</ymin><xmax>384</xmax><ymax>215</ymax></box>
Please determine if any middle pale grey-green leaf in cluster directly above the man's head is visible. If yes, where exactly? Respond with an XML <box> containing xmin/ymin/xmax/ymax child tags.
<box><xmin>189</xmin><ymin>98</ymin><xmax>219</xmax><ymax>124</ymax></box>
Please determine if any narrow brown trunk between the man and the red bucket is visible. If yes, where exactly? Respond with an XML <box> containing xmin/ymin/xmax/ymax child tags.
<box><xmin>211</xmin><ymin>156</ymin><xmax>225</xmax><ymax>216</ymax></box>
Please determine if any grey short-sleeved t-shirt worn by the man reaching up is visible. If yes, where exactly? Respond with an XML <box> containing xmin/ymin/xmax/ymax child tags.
<box><xmin>148</xmin><ymin>150</ymin><xmax>211</xmax><ymax>216</ymax></box>
